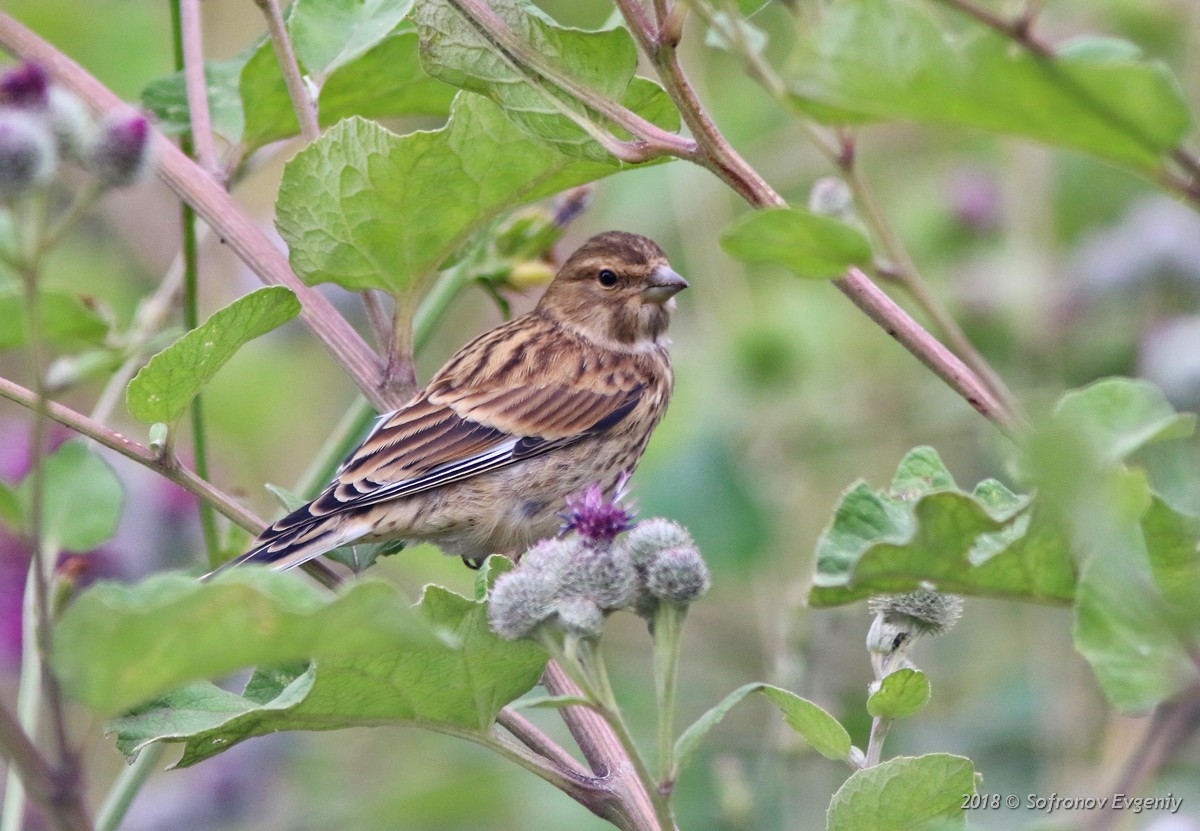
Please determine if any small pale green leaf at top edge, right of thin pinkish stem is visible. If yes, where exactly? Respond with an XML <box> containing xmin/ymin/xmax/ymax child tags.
<box><xmin>288</xmin><ymin>0</ymin><xmax>413</xmax><ymax>84</ymax></box>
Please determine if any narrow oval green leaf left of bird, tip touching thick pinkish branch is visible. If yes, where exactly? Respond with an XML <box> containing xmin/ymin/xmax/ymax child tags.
<box><xmin>126</xmin><ymin>286</ymin><xmax>300</xmax><ymax>424</ymax></box>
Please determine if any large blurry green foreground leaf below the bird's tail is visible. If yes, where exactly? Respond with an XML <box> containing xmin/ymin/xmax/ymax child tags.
<box><xmin>54</xmin><ymin>567</ymin><xmax>443</xmax><ymax>713</ymax></box>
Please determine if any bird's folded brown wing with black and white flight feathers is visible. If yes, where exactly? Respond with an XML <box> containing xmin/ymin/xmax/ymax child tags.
<box><xmin>300</xmin><ymin>317</ymin><xmax>644</xmax><ymax>516</ymax></box>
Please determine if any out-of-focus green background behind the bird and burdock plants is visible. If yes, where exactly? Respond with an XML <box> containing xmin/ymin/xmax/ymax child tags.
<box><xmin>0</xmin><ymin>0</ymin><xmax>1200</xmax><ymax>831</ymax></box>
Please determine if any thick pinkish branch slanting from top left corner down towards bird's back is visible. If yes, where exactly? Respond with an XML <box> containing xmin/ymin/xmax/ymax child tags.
<box><xmin>0</xmin><ymin>12</ymin><xmax>388</xmax><ymax>411</ymax></box>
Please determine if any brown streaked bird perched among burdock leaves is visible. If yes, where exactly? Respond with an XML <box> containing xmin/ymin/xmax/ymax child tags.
<box><xmin>208</xmin><ymin>231</ymin><xmax>688</xmax><ymax>570</ymax></box>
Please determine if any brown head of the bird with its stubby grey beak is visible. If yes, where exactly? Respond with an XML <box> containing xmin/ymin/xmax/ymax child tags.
<box><xmin>538</xmin><ymin>231</ymin><xmax>688</xmax><ymax>347</ymax></box>
